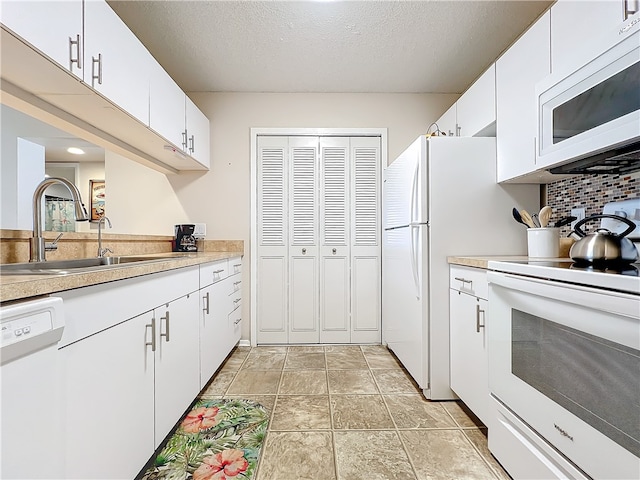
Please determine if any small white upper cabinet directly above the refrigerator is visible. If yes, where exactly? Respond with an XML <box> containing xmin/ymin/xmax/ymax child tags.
<box><xmin>436</xmin><ymin>64</ymin><xmax>496</xmax><ymax>137</ymax></box>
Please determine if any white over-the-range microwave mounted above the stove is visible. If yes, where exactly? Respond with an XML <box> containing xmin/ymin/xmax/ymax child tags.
<box><xmin>536</xmin><ymin>30</ymin><xmax>640</xmax><ymax>173</ymax></box>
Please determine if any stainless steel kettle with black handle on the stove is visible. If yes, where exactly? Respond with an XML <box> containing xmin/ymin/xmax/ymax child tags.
<box><xmin>569</xmin><ymin>214</ymin><xmax>638</xmax><ymax>263</ymax></box>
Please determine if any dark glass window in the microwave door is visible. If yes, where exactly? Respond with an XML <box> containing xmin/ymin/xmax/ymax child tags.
<box><xmin>553</xmin><ymin>62</ymin><xmax>640</xmax><ymax>144</ymax></box>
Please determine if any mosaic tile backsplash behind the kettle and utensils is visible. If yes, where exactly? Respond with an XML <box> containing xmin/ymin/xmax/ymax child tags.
<box><xmin>547</xmin><ymin>170</ymin><xmax>640</xmax><ymax>234</ymax></box>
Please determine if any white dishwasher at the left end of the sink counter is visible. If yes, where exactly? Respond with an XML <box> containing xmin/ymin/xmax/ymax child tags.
<box><xmin>0</xmin><ymin>297</ymin><xmax>64</xmax><ymax>480</ymax></box>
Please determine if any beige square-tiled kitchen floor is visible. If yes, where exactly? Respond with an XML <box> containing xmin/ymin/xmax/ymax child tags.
<box><xmin>198</xmin><ymin>346</ymin><xmax>509</xmax><ymax>480</ymax></box>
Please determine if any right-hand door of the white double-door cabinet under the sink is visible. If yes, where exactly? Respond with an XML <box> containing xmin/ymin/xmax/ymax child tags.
<box><xmin>154</xmin><ymin>294</ymin><xmax>200</xmax><ymax>447</ymax></box>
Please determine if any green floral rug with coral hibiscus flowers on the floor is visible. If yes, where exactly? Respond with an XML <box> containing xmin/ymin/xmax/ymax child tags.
<box><xmin>137</xmin><ymin>399</ymin><xmax>269</xmax><ymax>480</ymax></box>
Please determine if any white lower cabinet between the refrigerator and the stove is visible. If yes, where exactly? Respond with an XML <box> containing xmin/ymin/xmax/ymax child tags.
<box><xmin>449</xmin><ymin>266</ymin><xmax>495</xmax><ymax>426</ymax></box>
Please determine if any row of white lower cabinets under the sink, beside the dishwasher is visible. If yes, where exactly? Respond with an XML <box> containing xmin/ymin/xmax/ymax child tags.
<box><xmin>56</xmin><ymin>259</ymin><xmax>240</xmax><ymax>479</ymax></box>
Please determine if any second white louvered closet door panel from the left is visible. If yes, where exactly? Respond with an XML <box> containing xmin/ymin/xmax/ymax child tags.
<box><xmin>289</xmin><ymin>137</ymin><xmax>320</xmax><ymax>343</ymax></box>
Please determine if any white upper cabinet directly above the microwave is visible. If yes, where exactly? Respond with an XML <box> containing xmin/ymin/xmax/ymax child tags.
<box><xmin>551</xmin><ymin>0</ymin><xmax>640</xmax><ymax>74</ymax></box>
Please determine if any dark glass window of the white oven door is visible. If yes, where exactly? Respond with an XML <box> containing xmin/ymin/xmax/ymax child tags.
<box><xmin>511</xmin><ymin>309</ymin><xmax>640</xmax><ymax>457</ymax></box>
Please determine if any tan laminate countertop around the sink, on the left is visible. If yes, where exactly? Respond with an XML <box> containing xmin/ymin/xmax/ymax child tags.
<box><xmin>0</xmin><ymin>251</ymin><xmax>243</xmax><ymax>302</ymax></box>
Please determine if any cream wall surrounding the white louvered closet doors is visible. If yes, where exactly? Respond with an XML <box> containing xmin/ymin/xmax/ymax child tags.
<box><xmin>172</xmin><ymin>93</ymin><xmax>458</xmax><ymax>339</ymax></box>
